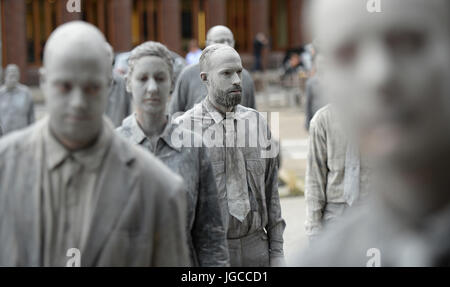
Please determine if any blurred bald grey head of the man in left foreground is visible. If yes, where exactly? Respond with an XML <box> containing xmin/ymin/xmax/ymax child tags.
<box><xmin>41</xmin><ymin>23</ymin><xmax>111</xmax><ymax>146</ymax></box>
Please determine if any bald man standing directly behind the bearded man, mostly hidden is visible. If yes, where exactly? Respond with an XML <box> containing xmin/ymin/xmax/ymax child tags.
<box><xmin>169</xmin><ymin>25</ymin><xmax>256</xmax><ymax>115</ymax></box>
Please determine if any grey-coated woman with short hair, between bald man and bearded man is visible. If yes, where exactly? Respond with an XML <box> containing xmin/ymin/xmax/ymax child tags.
<box><xmin>117</xmin><ymin>42</ymin><xmax>229</xmax><ymax>267</ymax></box>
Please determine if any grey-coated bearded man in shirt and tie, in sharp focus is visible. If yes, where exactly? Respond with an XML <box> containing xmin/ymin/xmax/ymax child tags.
<box><xmin>176</xmin><ymin>44</ymin><xmax>285</xmax><ymax>266</ymax></box>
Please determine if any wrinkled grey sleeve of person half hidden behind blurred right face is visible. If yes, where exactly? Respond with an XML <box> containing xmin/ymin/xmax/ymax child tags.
<box><xmin>305</xmin><ymin>117</ymin><xmax>328</xmax><ymax>237</ymax></box>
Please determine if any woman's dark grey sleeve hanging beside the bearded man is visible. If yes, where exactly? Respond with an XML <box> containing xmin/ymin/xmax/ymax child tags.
<box><xmin>192</xmin><ymin>148</ymin><xmax>229</xmax><ymax>267</ymax></box>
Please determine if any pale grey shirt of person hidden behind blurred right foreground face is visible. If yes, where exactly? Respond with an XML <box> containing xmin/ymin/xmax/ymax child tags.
<box><xmin>305</xmin><ymin>105</ymin><xmax>369</xmax><ymax>236</ymax></box>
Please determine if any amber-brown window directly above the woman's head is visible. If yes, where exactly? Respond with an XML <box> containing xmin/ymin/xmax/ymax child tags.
<box><xmin>131</xmin><ymin>0</ymin><xmax>162</xmax><ymax>46</ymax></box>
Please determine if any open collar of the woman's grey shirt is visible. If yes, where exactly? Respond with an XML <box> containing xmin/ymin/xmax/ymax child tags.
<box><xmin>123</xmin><ymin>113</ymin><xmax>181</xmax><ymax>152</ymax></box>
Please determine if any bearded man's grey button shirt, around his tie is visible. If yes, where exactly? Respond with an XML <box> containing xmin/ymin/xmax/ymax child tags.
<box><xmin>176</xmin><ymin>98</ymin><xmax>285</xmax><ymax>257</ymax></box>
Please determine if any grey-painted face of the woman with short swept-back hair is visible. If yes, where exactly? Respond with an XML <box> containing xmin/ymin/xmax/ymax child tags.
<box><xmin>129</xmin><ymin>56</ymin><xmax>172</xmax><ymax>113</ymax></box>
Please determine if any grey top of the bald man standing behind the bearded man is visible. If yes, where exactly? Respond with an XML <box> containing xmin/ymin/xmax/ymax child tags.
<box><xmin>169</xmin><ymin>64</ymin><xmax>256</xmax><ymax>115</ymax></box>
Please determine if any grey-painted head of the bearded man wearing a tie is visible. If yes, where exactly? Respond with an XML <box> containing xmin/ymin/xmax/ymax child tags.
<box><xmin>202</xmin><ymin>47</ymin><xmax>242</xmax><ymax>109</ymax></box>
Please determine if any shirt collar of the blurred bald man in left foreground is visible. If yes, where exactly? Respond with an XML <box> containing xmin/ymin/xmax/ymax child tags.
<box><xmin>43</xmin><ymin>117</ymin><xmax>112</xmax><ymax>170</ymax></box>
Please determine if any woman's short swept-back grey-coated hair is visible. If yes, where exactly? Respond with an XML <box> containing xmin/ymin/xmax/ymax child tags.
<box><xmin>127</xmin><ymin>41</ymin><xmax>174</xmax><ymax>84</ymax></box>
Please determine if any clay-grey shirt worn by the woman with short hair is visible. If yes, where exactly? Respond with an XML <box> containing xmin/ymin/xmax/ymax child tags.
<box><xmin>117</xmin><ymin>114</ymin><xmax>229</xmax><ymax>267</ymax></box>
